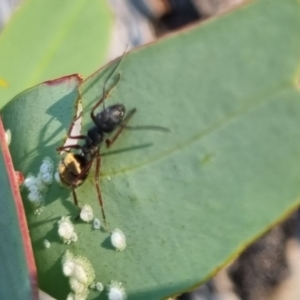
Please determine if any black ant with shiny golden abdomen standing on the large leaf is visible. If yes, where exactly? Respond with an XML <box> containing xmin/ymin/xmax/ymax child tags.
<box><xmin>56</xmin><ymin>54</ymin><xmax>170</xmax><ymax>227</ymax></box>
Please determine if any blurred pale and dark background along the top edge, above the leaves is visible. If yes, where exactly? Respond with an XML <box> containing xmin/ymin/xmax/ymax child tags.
<box><xmin>0</xmin><ymin>0</ymin><xmax>244</xmax><ymax>60</ymax></box>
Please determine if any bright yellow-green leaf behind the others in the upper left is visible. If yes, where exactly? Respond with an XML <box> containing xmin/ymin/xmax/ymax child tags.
<box><xmin>0</xmin><ymin>0</ymin><xmax>112</xmax><ymax>107</ymax></box>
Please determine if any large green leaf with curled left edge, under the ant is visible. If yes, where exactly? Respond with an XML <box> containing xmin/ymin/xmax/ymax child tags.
<box><xmin>2</xmin><ymin>0</ymin><xmax>300</xmax><ymax>299</ymax></box>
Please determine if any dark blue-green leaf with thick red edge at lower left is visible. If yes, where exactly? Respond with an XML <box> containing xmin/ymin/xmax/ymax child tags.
<box><xmin>0</xmin><ymin>118</ymin><xmax>38</xmax><ymax>300</ymax></box>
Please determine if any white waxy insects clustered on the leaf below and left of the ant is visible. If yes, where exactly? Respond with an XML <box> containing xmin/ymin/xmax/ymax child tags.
<box><xmin>19</xmin><ymin>157</ymin><xmax>127</xmax><ymax>300</ymax></box>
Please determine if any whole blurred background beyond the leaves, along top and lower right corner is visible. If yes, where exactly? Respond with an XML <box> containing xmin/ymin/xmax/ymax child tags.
<box><xmin>0</xmin><ymin>0</ymin><xmax>300</xmax><ymax>300</ymax></box>
